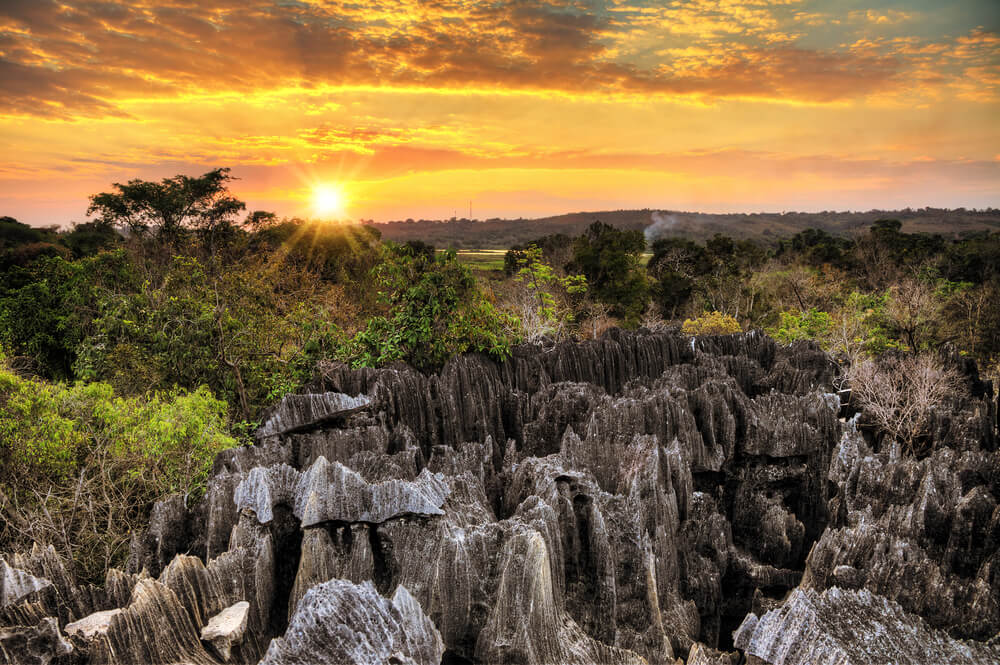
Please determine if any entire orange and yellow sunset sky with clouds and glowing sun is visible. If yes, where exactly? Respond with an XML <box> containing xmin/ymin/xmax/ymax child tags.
<box><xmin>0</xmin><ymin>0</ymin><xmax>1000</xmax><ymax>225</ymax></box>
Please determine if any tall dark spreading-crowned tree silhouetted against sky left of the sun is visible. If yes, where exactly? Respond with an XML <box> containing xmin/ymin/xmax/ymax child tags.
<box><xmin>87</xmin><ymin>168</ymin><xmax>246</xmax><ymax>243</ymax></box>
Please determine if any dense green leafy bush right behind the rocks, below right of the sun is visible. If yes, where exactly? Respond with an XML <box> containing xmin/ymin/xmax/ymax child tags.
<box><xmin>346</xmin><ymin>246</ymin><xmax>518</xmax><ymax>370</ymax></box>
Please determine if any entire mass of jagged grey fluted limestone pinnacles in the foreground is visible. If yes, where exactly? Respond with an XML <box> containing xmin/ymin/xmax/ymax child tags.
<box><xmin>0</xmin><ymin>330</ymin><xmax>1000</xmax><ymax>665</ymax></box>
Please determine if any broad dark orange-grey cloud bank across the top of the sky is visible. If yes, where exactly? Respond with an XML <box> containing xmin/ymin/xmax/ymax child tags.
<box><xmin>0</xmin><ymin>0</ymin><xmax>996</xmax><ymax>117</ymax></box>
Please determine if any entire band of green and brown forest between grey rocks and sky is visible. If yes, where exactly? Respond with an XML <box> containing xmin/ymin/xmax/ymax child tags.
<box><xmin>0</xmin><ymin>169</ymin><xmax>1000</xmax><ymax>579</ymax></box>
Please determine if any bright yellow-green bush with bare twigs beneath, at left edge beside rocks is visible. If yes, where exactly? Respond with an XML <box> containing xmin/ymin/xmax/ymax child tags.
<box><xmin>0</xmin><ymin>356</ymin><xmax>237</xmax><ymax>581</ymax></box>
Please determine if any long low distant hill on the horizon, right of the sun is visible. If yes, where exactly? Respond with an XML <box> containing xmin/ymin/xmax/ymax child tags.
<box><xmin>374</xmin><ymin>208</ymin><xmax>1000</xmax><ymax>249</ymax></box>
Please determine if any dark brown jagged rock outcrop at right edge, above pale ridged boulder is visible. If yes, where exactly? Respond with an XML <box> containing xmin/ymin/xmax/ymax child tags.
<box><xmin>802</xmin><ymin>416</ymin><xmax>1000</xmax><ymax>640</ymax></box>
